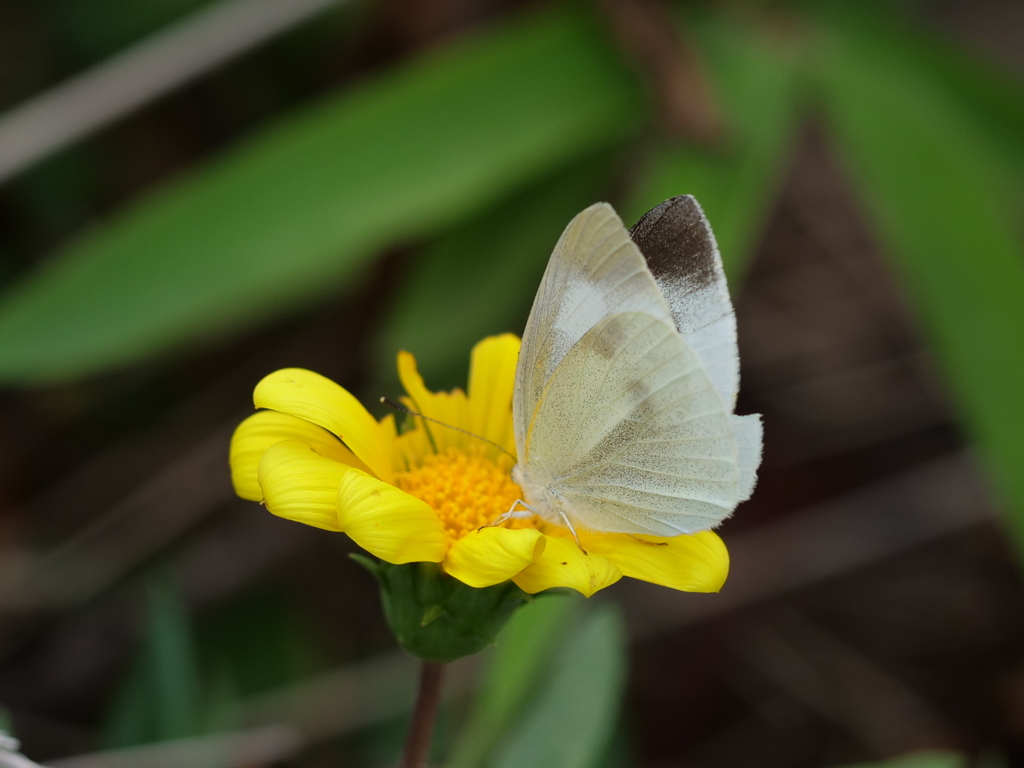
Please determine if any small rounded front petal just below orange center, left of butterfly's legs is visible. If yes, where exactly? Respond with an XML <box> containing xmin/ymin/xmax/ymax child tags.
<box><xmin>444</xmin><ymin>527</ymin><xmax>545</xmax><ymax>587</ymax></box>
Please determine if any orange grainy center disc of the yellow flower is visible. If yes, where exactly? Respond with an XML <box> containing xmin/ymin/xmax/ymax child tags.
<box><xmin>395</xmin><ymin>449</ymin><xmax>530</xmax><ymax>542</ymax></box>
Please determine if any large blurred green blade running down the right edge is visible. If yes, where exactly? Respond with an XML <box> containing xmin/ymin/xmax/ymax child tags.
<box><xmin>817</xmin><ymin>19</ymin><xmax>1024</xmax><ymax>544</ymax></box>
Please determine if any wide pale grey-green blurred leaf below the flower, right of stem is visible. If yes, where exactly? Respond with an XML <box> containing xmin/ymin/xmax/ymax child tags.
<box><xmin>488</xmin><ymin>606</ymin><xmax>626</xmax><ymax>768</ymax></box>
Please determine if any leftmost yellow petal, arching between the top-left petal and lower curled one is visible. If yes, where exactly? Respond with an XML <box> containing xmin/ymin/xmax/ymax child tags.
<box><xmin>229</xmin><ymin>411</ymin><xmax>366</xmax><ymax>502</ymax></box>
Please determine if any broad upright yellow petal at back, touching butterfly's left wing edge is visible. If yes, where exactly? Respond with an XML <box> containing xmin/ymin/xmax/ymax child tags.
<box><xmin>469</xmin><ymin>334</ymin><xmax>519</xmax><ymax>462</ymax></box>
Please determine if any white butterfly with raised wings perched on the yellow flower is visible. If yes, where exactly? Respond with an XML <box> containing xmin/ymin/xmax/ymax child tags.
<box><xmin>513</xmin><ymin>196</ymin><xmax>762</xmax><ymax>537</ymax></box>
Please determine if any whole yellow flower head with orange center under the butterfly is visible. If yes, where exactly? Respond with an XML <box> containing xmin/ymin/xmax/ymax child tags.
<box><xmin>230</xmin><ymin>335</ymin><xmax>729</xmax><ymax>597</ymax></box>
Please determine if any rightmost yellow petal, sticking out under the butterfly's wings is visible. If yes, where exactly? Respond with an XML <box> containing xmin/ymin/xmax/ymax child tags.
<box><xmin>580</xmin><ymin>530</ymin><xmax>729</xmax><ymax>592</ymax></box>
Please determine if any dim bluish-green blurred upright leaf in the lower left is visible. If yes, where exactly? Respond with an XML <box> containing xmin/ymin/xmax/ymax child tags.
<box><xmin>104</xmin><ymin>577</ymin><xmax>205</xmax><ymax>746</ymax></box>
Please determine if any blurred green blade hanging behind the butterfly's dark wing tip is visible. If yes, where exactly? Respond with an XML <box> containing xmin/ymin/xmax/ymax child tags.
<box><xmin>627</xmin><ymin>10</ymin><xmax>801</xmax><ymax>274</ymax></box>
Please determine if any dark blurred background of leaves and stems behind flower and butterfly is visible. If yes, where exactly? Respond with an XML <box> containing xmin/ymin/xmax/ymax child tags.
<box><xmin>0</xmin><ymin>0</ymin><xmax>1024</xmax><ymax>768</ymax></box>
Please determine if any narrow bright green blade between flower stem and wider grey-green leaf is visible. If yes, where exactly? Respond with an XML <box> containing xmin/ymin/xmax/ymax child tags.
<box><xmin>445</xmin><ymin>595</ymin><xmax>580</xmax><ymax>768</ymax></box>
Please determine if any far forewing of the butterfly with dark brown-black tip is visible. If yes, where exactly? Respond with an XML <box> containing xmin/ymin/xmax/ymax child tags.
<box><xmin>630</xmin><ymin>195</ymin><xmax>739</xmax><ymax>410</ymax></box>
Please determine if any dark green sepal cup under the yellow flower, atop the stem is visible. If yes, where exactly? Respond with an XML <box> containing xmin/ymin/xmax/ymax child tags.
<box><xmin>349</xmin><ymin>554</ymin><xmax>531</xmax><ymax>664</ymax></box>
